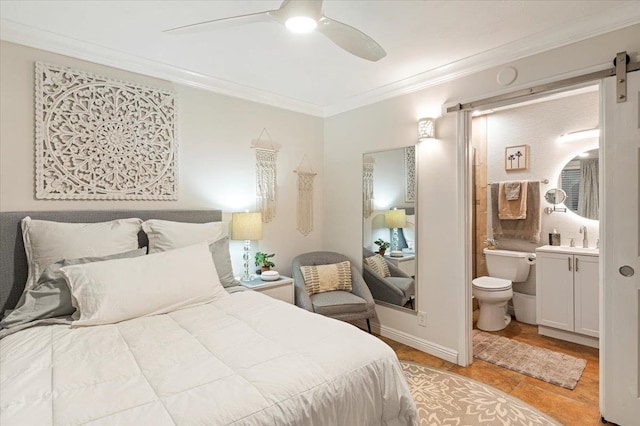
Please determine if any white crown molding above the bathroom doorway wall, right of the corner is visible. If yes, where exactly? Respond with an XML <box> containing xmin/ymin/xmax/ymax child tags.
<box><xmin>324</xmin><ymin>2</ymin><xmax>640</xmax><ymax>117</ymax></box>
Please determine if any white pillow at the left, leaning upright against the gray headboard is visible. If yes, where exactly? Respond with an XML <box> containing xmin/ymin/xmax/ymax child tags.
<box><xmin>21</xmin><ymin>216</ymin><xmax>142</xmax><ymax>292</ymax></box>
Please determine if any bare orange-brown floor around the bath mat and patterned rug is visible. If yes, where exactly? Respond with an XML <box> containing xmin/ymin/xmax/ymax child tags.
<box><xmin>381</xmin><ymin>320</ymin><xmax>601</xmax><ymax>426</ymax></box>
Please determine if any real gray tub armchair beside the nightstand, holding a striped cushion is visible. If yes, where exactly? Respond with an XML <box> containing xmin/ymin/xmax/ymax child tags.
<box><xmin>291</xmin><ymin>251</ymin><xmax>376</xmax><ymax>333</ymax></box>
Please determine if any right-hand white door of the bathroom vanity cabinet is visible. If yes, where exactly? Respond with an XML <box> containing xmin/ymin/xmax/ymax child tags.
<box><xmin>574</xmin><ymin>255</ymin><xmax>600</xmax><ymax>337</ymax></box>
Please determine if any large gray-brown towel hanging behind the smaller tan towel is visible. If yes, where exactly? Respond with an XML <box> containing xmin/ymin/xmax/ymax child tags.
<box><xmin>491</xmin><ymin>182</ymin><xmax>542</xmax><ymax>243</ymax></box>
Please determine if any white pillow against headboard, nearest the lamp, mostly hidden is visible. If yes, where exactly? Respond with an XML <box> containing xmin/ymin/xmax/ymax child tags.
<box><xmin>142</xmin><ymin>219</ymin><xmax>228</xmax><ymax>254</ymax></box>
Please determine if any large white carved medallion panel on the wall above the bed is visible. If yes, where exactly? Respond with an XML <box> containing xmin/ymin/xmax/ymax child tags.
<box><xmin>36</xmin><ymin>62</ymin><xmax>178</xmax><ymax>200</ymax></box>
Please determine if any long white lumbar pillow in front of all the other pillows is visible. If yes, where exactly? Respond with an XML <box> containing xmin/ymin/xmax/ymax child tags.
<box><xmin>60</xmin><ymin>243</ymin><xmax>229</xmax><ymax>326</ymax></box>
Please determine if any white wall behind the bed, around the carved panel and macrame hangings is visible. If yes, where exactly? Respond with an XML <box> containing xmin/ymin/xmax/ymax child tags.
<box><xmin>0</xmin><ymin>42</ymin><xmax>323</xmax><ymax>275</ymax></box>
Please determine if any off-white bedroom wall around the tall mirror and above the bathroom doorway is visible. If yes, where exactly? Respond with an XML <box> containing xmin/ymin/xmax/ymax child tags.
<box><xmin>324</xmin><ymin>25</ymin><xmax>640</xmax><ymax>363</ymax></box>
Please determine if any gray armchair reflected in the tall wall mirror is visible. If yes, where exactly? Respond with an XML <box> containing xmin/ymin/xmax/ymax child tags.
<box><xmin>362</xmin><ymin>248</ymin><xmax>416</xmax><ymax>309</ymax></box>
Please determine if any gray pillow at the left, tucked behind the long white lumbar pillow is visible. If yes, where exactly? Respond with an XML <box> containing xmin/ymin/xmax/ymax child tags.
<box><xmin>0</xmin><ymin>248</ymin><xmax>147</xmax><ymax>328</ymax></box>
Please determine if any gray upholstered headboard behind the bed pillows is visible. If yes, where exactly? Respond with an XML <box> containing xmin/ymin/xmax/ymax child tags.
<box><xmin>0</xmin><ymin>210</ymin><xmax>222</xmax><ymax>314</ymax></box>
